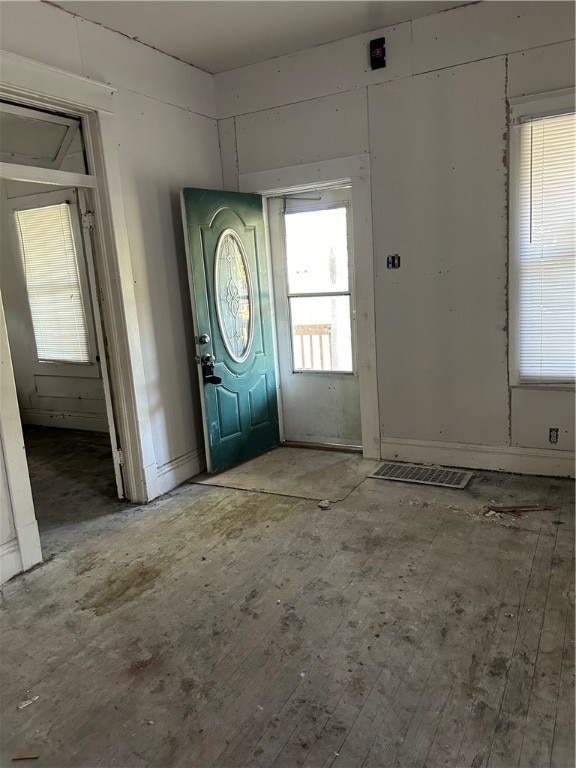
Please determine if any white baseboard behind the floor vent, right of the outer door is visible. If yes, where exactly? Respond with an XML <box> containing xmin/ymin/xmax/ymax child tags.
<box><xmin>382</xmin><ymin>438</ymin><xmax>575</xmax><ymax>477</ymax></box>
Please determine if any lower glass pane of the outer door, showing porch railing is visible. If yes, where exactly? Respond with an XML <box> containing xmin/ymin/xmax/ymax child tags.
<box><xmin>290</xmin><ymin>296</ymin><xmax>353</xmax><ymax>371</ymax></box>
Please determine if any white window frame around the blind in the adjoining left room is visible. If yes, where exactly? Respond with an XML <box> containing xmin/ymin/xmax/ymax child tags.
<box><xmin>7</xmin><ymin>189</ymin><xmax>101</xmax><ymax>378</ymax></box>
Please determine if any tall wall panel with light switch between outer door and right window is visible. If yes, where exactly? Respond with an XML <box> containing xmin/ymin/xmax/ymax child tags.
<box><xmin>369</xmin><ymin>57</ymin><xmax>508</xmax><ymax>445</ymax></box>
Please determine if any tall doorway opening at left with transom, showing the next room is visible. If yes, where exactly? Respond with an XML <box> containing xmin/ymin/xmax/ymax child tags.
<box><xmin>0</xmin><ymin>102</ymin><xmax>126</xmax><ymax>531</ymax></box>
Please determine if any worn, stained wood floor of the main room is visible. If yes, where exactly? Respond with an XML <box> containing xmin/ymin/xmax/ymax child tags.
<box><xmin>0</xmin><ymin>460</ymin><xmax>574</xmax><ymax>768</ymax></box>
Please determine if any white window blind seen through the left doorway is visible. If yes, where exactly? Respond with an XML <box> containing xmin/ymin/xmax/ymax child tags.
<box><xmin>14</xmin><ymin>203</ymin><xmax>90</xmax><ymax>363</ymax></box>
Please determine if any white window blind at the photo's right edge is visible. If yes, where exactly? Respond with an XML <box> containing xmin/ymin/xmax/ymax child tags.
<box><xmin>516</xmin><ymin>114</ymin><xmax>576</xmax><ymax>383</ymax></box>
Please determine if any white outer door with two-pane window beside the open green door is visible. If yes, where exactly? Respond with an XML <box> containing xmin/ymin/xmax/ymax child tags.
<box><xmin>268</xmin><ymin>184</ymin><xmax>362</xmax><ymax>450</ymax></box>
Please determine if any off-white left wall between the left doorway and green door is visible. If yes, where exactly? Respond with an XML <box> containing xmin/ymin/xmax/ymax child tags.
<box><xmin>0</xmin><ymin>2</ymin><xmax>222</xmax><ymax>495</ymax></box>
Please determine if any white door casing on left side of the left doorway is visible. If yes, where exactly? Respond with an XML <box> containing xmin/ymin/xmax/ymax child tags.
<box><xmin>0</xmin><ymin>296</ymin><xmax>42</xmax><ymax>578</ymax></box>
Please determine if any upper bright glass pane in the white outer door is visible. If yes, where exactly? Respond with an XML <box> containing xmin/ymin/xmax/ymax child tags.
<box><xmin>285</xmin><ymin>206</ymin><xmax>348</xmax><ymax>293</ymax></box>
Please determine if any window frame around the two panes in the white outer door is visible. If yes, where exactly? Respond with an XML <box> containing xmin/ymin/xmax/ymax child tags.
<box><xmin>282</xmin><ymin>185</ymin><xmax>358</xmax><ymax>376</ymax></box>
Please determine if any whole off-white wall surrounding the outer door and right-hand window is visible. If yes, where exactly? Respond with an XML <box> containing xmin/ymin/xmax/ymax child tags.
<box><xmin>215</xmin><ymin>2</ymin><xmax>574</xmax><ymax>474</ymax></box>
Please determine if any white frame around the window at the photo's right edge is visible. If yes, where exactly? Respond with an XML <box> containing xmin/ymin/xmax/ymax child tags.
<box><xmin>508</xmin><ymin>88</ymin><xmax>576</xmax><ymax>391</ymax></box>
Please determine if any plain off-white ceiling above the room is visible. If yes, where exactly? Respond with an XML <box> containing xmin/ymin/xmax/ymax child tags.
<box><xmin>52</xmin><ymin>0</ymin><xmax>472</xmax><ymax>73</ymax></box>
